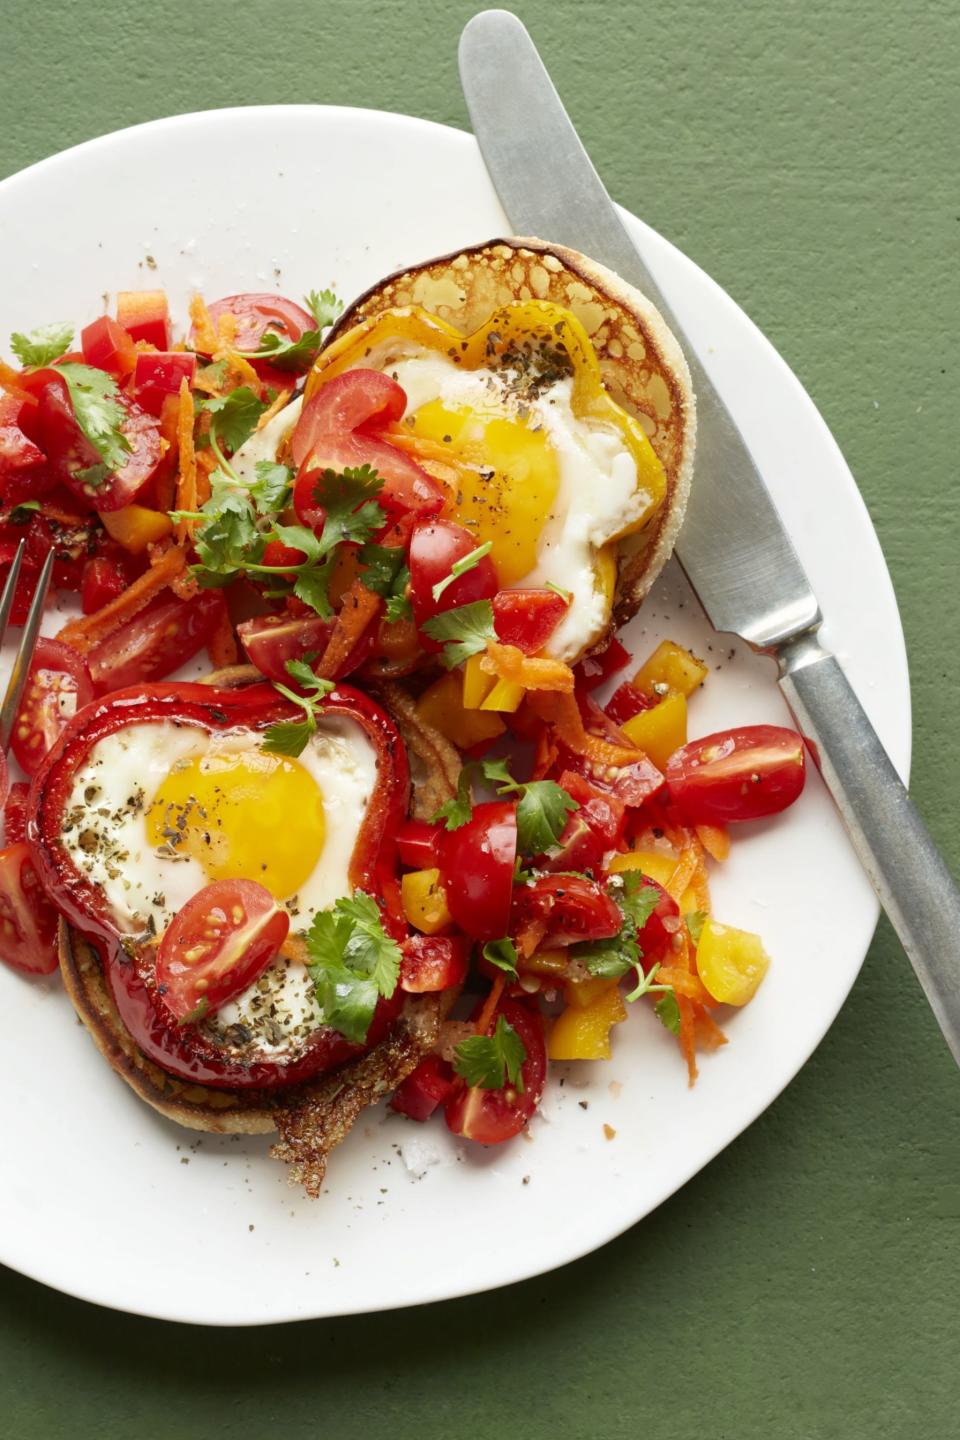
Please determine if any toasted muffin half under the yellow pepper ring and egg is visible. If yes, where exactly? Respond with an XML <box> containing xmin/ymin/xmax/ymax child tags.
<box><xmin>324</xmin><ymin>238</ymin><xmax>697</xmax><ymax>636</ymax></box>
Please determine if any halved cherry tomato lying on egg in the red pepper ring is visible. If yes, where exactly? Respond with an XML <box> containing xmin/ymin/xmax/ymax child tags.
<box><xmin>157</xmin><ymin>880</ymin><xmax>289</xmax><ymax>1020</ymax></box>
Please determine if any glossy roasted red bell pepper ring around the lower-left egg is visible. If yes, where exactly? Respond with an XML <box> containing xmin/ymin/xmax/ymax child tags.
<box><xmin>27</xmin><ymin>684</ymin><xmax>410</xmax><ymax>1089</ymax></box>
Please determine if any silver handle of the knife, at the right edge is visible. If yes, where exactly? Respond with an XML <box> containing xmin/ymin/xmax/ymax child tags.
<box><xmin>777</xmin><ymin>632</ymin><xmax>960</xmax><ymax>1064</ymax></box>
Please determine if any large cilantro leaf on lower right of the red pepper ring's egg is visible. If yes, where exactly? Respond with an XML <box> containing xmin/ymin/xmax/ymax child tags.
<box><xmin>307</xmin><ymin>890</ymin><xmax>400</xmax><ymax>1044</ymax></box>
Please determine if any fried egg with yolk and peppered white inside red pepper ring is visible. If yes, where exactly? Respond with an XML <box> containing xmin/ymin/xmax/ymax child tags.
<box><xmin>63</xmin><ymin>716</ymin><xmax>377</xmax><ymax>1054</ymax></box>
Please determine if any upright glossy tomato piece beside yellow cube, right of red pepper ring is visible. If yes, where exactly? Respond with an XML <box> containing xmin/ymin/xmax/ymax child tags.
<box><xmin>440</xmin><ymin>801</ymin><xmax>517</xmax><ymax>940</ymax></box>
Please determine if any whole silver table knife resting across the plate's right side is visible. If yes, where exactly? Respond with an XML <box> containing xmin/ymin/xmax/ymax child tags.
<box><xmin>459</xmin><ymin>10</ymin><xmax>960</xmax><ymax>1064</ymax></box>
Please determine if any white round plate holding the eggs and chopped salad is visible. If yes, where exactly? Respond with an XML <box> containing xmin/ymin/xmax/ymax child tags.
<box><xmin>0</xmin><ymin>107</ymin><xmax>910</xmax><ymax>1325</ymax></box>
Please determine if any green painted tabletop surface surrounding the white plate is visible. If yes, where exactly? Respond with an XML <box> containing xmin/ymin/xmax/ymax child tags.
<box><xmin>0</xmin><ymin>0</ymin><xmax>960</xmax><ymax>1440</ymax></box>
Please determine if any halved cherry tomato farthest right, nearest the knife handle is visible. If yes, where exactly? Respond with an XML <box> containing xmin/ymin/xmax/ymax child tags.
<box><xmin>666</xmin><ymin>724</ymin><xmax>806</xmax><ymax>825</ymax></box>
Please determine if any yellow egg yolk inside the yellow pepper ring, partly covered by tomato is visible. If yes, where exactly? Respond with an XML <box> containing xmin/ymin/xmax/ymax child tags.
<box><xmin>409</xmin><ymin>400</ymin><xmax>560</xmax><ymax>585</ymax></box>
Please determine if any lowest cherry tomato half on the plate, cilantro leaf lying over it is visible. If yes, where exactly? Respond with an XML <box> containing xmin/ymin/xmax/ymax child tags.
<box><xmin>443</xmin><ymin>999</ymin><xmax>547</xmax><ymax>1145</ymax></box>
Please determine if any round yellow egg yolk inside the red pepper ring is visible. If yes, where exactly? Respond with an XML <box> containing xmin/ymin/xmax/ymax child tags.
<box><xmin>147</xmin><ymin>750</ymin><xmax>325</xmax><ymax>900</ymax></box>
